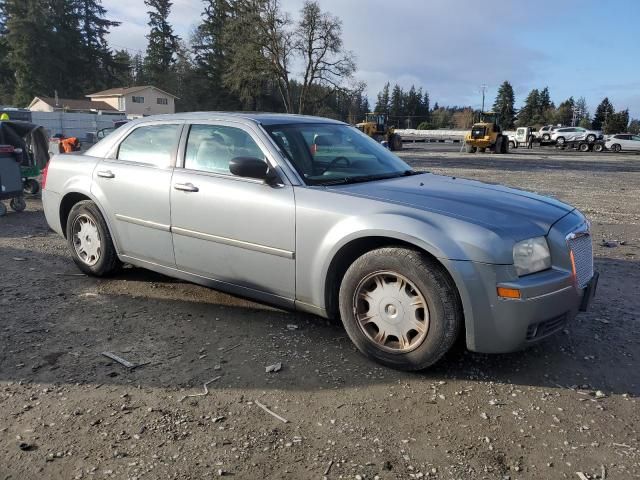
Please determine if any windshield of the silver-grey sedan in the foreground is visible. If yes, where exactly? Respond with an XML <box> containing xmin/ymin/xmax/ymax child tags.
<box><xmin>265</xmin><ymin>123</ymin><xmax>413</xmax><ymax>185</ymax></box>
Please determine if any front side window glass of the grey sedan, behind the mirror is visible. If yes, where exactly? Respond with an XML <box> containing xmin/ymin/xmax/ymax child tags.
<box><xmin>184</xmin><ymin>125</ymin><xmax>265</xmax><ymax>175</ymax></box>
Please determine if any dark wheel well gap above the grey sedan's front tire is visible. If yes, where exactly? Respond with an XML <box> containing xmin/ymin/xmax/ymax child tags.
<box><xmin>324</xmin><ymin>237</ymin><xmax>464</xmax><ymax>325</ymax></box>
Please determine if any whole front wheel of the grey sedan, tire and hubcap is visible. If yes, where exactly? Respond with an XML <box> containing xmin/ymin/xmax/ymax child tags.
<box><xmin>339</xmin><ymin>247</ymin><xmax>462</xmax><ymax>370</ymax></box>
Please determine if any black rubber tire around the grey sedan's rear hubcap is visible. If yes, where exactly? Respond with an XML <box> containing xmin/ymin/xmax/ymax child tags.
<box><xmin>66</xmin><ymin>200</ymin><xmax>121</xmax><ymax>277</ymax></box>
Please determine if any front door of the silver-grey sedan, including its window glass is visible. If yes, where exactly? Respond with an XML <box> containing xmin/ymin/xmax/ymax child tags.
<box><xmin>171</xmin><ymin>122</ymin><xmax>295</xmax><ymax>300</ymax></box>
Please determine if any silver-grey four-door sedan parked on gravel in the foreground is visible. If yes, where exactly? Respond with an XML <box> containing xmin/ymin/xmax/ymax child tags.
<box><xmin>43</xmin><ymin>112</ymin><xmax>598</xmax><ymax>370</ymax></box>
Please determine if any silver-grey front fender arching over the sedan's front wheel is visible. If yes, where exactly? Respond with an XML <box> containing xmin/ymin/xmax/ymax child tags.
<box><xmin>296</xmin><ymin>190</ymin><xmax>512</xmax><ymax>309</ymax></box>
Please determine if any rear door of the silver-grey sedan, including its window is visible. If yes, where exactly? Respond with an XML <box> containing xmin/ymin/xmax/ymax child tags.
<box><xmin>91</xmin><ymin>122</ymin><xmax>183</xmax><ymax>266</ymax></box>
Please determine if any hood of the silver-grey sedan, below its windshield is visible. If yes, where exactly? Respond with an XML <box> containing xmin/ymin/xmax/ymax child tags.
<box><xmin>329</xmin><ymin>173</ymin><xmax>574</xmax><ymax>241</ymax></box>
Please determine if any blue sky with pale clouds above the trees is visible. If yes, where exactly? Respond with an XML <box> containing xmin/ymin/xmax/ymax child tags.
<box><xmin>103</xmin><ymin>0</ymin><xmax>640</xmax><ymax>117</ymax></box>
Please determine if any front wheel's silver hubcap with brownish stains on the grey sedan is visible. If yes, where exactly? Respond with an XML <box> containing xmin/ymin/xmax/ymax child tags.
<box><xmin>353</xmin><ymin>271</ymin><xmax>429</xmax><ymax>353</ymax></box>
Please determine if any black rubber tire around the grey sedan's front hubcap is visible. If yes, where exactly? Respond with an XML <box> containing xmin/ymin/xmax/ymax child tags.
<box><xmin>339</xmin><ymin>247</ymin><xmax>463</xmax><ymax>370</ymax></box>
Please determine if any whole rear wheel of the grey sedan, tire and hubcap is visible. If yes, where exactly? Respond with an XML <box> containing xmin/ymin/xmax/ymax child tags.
<box><xmin>67</xmin><ymin>200</ymin><xmax>120</xmax><ymax>277</ymax></box>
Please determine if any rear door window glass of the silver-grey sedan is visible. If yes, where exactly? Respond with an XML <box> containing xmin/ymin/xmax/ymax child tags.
<box><xmin>118</xmin><ymin>124</ymin><xmax>182</xmax><ymax>167</ymax></box>
